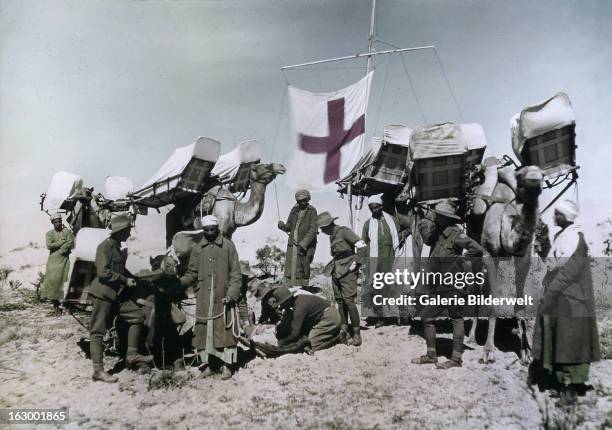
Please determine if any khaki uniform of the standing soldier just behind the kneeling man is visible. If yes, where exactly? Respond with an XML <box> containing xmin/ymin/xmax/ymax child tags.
<box><xmin>324</xmin><ymin>225</ymin><xmax>367</xmax><ymax>336</ymax></box>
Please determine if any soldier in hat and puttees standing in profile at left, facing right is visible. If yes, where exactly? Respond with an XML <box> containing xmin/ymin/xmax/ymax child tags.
<box><xmin>89</xmin><ymin>214</ymin><xmax>153</xmax><ymax>382</ymax></box>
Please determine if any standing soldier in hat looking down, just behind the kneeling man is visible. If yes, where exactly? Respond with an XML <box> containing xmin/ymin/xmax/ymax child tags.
<box><xmin>317</xmin><ymin>212</ymin><xmax>367</xmax><ymax>346</ymax></box>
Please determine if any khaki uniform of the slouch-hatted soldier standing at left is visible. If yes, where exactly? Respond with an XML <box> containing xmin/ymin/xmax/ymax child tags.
<box><xmin>89</xmin><ymin>236</ymin><xmax>145</xmax><ymax>369</ymax></box>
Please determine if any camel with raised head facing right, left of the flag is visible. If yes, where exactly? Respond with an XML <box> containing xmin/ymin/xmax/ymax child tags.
<box><xmin>166</xmin><ymin>163</ymin><xmax>285</xmax><ymax>252</ymax></box>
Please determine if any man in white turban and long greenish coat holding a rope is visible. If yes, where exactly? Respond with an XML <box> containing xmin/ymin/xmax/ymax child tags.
<box><xmin>180</xmin><ymin>215</ymin><xmax>242</xmax><ymax>379</ymax></box>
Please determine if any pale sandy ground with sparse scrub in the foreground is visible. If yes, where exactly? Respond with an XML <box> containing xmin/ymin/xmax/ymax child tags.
<box><xmin>0</xmin><ymin>246</ymin><xmax>612</xmax><ymax>429</ymax></box>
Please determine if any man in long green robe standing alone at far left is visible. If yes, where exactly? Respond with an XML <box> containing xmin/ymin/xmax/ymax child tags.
<box><xmin>40</xmin><ymin>212</ymin><xmax>74</xmax><ymax>315</ymax></box>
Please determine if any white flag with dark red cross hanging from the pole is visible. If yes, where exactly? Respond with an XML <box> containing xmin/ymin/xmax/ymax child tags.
<box><xmin>287</xmin><ymin>72</ymin><xmax>374</xmax><ymax>190</ymax></box>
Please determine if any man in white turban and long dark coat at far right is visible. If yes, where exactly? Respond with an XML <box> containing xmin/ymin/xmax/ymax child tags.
<box><xmin>529</xmin><ymin>200</ymin><xmax>601</xmax><ymax>406</ymax></box>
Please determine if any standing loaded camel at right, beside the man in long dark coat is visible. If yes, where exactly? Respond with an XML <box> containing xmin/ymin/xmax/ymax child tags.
<box><xmin>467</xmin><ymin>158</ymin><xmax>544</xmax><ymax>364</ymax></box>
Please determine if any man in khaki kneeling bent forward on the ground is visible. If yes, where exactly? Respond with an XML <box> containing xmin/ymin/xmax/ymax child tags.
<box><xmin>272</xmin><ymin>285</ymin><xmax>342</xmax><ymax>351</ymax></box>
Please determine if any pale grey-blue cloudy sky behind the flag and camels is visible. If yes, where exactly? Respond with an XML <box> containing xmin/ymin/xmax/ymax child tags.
<box><xmin>0</xmin><ymin>0</ymin><xmax>612</xmax><ymax>261</ymax></box>
